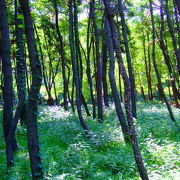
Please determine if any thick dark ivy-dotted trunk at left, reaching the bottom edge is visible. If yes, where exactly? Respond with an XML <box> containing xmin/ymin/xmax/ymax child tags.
<box><xmin>19</xmin><ymin>0</ymin><xmax>43</xmax><ymax>180</ymax></box>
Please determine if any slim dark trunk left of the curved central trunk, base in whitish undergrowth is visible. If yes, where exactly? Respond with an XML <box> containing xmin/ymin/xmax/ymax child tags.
<box><xmin>53</xmin><ymin>0</ymin><xmax>68</xmax><ymax>111</ymax></box>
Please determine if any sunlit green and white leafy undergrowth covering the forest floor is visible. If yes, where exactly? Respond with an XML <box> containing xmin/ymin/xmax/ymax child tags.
<box><xmin>0</xmin><ymin>103</ymin><xmax>180</xmax><ymax>180</ymax></box>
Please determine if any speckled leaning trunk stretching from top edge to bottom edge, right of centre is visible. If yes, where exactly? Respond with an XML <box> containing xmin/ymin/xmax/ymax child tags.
<box><xmin>104</xmin><ymin>0</ymin><xmax>149</xmax><ymax>180</ymax></box>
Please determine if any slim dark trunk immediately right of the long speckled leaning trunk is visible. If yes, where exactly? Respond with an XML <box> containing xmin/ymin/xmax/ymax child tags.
<box><xmin>118</xmin><ymin>0</ymin><xmax>137</xmax><ymax>118</ymax></box>
